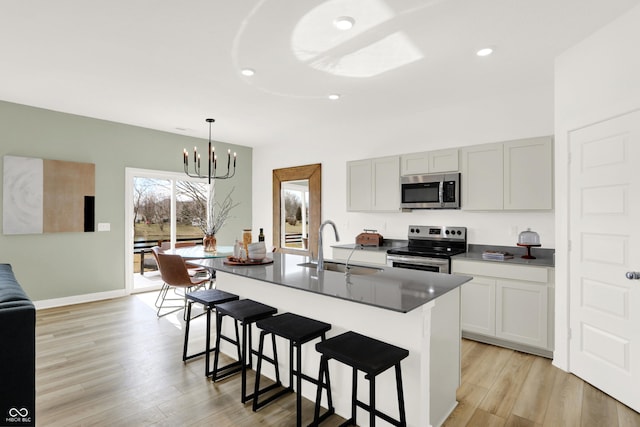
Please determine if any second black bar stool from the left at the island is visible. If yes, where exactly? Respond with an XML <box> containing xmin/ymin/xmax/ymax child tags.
<box><xmin>211</xmin><ymin>299</ymin><xmax>278</xmax><ymax>403</ymax></box>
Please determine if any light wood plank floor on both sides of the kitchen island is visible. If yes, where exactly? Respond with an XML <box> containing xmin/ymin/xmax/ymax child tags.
<box><xmin>36</xmin><ymin>294</ymin><xmax>640</xmax><ymax>427</ymax></box>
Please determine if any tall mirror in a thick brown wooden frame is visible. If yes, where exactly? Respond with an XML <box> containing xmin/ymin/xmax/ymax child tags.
<box><xmin>273</xmin><ymin>163</ymin><xmax>322</xmax><ymax>257</ymax></box>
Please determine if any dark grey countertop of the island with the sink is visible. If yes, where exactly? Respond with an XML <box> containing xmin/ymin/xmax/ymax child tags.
<box><xmin>190</xmin><ymin>253</ymin><xmax>471</xmax><ymax>313</ymax></box>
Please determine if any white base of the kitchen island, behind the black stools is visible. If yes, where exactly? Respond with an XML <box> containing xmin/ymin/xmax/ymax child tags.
<box><xmin>216</xmin><ymin>271</ymin><xmax>460</xmax><ymax>427</ymax></box>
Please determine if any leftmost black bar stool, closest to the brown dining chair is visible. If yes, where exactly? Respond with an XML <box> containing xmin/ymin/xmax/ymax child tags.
<box><xmin>182</xmin><ymin>289</ymin><xmax>240</xmax><ymax>376</ymax></box>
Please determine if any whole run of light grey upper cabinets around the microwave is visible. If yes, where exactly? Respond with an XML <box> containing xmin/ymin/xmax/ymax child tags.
<box><xmin>347</xmin><ymin>136</ymin><xmax>553</xmax><ymax>212</ymax></box>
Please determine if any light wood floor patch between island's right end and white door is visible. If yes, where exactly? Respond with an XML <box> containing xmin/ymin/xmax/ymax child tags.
<box><xmin>444</xmin><ymin>340</ymin><xmax>640</xmax><ymax>427</ymax></box>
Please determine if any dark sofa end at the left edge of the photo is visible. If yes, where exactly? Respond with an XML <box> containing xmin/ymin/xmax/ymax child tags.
<box><xmin>0</xmin><ymin>264</ymin><xmax>36</xmax><ymax>426</ymax></box>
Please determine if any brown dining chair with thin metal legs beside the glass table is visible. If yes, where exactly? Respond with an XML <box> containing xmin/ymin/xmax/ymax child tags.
<box><xmin>152</xmin><ymin>252</ymin><xmax>210</xmax><ymax>320</ymax></box>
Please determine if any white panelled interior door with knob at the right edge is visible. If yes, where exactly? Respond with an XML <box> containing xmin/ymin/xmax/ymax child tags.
<box><xmin>569</xmin><ymin>111</ymin><xmax>640</xmax><ymax>411</ymax></box>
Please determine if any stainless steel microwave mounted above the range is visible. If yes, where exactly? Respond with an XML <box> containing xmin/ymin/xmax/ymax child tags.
<box><xmin>400</xmin><ymin>172</ymin><xmax>460</xmax><ymax>209</ymax></box>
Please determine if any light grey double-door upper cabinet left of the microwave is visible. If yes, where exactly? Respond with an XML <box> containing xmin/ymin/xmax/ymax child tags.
<box><xmin>347</xmin><ymin>156</ymin><xmax>400</xmax><ymax>212</ymax></box>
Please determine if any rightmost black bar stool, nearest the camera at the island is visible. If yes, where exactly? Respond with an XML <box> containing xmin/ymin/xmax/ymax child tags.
<box><xmin>313</xmin><ymin>331</ymin><xmax>409</xmax><ymax>427</ymax></box>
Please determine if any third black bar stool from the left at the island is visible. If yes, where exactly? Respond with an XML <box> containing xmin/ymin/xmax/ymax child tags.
<box><xmin>253</xmin><ymin>313</ymin><xmax>334</xmax><ymax>426</ymax></box>
